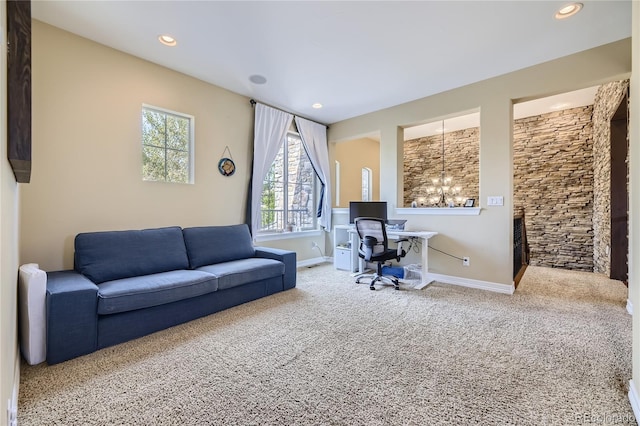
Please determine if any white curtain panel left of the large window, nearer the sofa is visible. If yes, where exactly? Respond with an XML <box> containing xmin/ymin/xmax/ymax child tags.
<box><xmin>251</xmin><ymin>104</ymin><xmax>293</xmax><ymax>237</ymax></box>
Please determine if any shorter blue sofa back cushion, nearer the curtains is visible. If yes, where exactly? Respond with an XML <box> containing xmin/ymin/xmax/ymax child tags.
<box><xmin>182</xmin><ymin>224</ymin><xmax>256</xmax><ymax>269</ymax></box>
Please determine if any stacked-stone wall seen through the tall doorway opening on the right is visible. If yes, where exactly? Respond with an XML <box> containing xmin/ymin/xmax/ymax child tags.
<box><xmin>513</xmin><ymin>106</ymin><xmax>594</xmax><ymax>271</ymax></box>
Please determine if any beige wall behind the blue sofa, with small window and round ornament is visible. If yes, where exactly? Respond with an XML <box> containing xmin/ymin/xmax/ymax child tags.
<box><xmin>20</xmin><ymin>21</ymin><xmax>320</xmax><ymax>270</ymax></box>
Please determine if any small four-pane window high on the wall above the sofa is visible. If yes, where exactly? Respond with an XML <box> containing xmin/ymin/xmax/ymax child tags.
<box><xmin>142</xmin><ymin>106</ymin><xmax>193</xmax><ymax>183</ymax></box>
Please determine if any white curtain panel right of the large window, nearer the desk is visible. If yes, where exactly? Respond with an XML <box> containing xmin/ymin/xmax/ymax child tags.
<box><xmin>296</xmin><ymin>117</ymin><xmax>331</xmax><ymax>231</ymax></box>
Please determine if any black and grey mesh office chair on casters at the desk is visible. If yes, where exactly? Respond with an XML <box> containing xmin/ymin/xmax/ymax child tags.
<box><xmin>355</xmin><ymin>217</ymin><xmax>409</xmax><ymax>290</ymax></box>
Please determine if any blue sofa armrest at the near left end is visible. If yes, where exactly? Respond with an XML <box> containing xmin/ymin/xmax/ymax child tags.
<box><xmin>47</xmin><ymin>271</ymin><xmax>98</xmax><ymax>364</ymax></box>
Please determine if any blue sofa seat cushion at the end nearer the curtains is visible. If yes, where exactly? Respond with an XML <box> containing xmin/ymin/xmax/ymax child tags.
<box><xmin>197</xmin><ymin>258</ymin><xmax>284</xmax><ymax>290</ymax></box>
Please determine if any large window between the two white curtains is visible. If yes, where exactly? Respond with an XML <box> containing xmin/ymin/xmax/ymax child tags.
<box><xmin>260</xmin><ymin>133</ymin><xmax>318</xmax><ymax>232</ymax></box>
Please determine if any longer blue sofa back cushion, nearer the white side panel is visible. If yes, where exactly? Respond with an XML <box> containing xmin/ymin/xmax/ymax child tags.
<box><xmin>75</xmin><ymin>226</ymin><xmax>189</xmax><ymax>284</ymax></box>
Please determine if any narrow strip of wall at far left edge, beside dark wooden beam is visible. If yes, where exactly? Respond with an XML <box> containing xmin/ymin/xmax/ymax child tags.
<box><xmin>0</xmin><ymin>1</ymin><xmax>20</xmax><ymax>425</ymax></box>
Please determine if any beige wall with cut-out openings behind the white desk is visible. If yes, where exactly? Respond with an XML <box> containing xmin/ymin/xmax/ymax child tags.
<box><xmin>329</xmin><ymin>39</ymin><xmax>631</xmax><ymax>284</ymax></box>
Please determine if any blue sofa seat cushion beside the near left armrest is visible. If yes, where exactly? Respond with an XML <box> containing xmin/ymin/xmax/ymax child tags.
<box><xmin>98</xmin><ymin>270</ymin><xmax>218</xmax><ymax>315</ymax></box>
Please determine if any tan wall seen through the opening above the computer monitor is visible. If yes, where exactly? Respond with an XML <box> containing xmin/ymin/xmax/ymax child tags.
<box><xmin>329</xmin><ymin>138</ymin><xmax>380</xmax><ymax>208</ymax></box>
